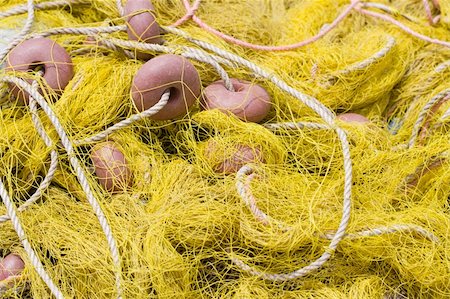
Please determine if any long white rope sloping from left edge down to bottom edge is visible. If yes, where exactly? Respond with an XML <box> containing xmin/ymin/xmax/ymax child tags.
<box><xmin>3</xmin><ymin>76</ymin><xmax>122</xmax><ymax>298</ymax></box>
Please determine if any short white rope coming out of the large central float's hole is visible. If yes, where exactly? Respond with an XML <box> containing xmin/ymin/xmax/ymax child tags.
<box><xmin>74</xmin><ymin>89</ymin><xmax>170</xmax><ymax>145</ymax></box>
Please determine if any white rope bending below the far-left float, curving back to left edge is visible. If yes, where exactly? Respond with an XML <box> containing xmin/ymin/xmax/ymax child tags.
<box><xmin>0</xmin><ymin>76</ymin><xmax>58</xmax><ymax>223</ymax></box>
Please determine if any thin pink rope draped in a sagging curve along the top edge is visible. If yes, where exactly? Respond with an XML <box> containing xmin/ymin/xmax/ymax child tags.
<box><xmin>171</xmin><ymin>0</ymin><xmax>450</xmax><ymax>51</ymax></box>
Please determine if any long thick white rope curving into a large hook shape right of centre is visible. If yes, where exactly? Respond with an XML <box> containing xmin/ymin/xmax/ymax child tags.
<box><xmin>164</xmin><ymin>27</ymin><xmax>352</xmax><ymax>281</ymax></box>
